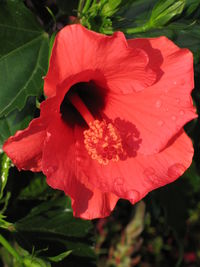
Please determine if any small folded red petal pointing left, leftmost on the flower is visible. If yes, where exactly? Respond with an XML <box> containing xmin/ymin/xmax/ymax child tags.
<box><xmin>3</xmin><ymin>119</ymin><xmax>46</xmax><ymax>172</ymax></box>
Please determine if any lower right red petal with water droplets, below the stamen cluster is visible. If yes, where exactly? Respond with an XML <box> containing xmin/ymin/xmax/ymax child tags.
<box><xmin>76</xmin><ymin>127</ymin><xmax>193</xmax><ymax>203</ymax></box>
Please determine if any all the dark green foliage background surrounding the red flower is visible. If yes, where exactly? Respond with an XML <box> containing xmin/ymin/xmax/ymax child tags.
<box><xmin>0</xmin><ymin>0</ymin><xmax>200</xmax><ymax>267</ymax></box>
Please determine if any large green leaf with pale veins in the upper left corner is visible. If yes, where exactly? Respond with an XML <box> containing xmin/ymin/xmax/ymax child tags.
<box><xmin>0</xmin><ymin>0</ymin><xmax>48</xmax><ymax>116</ymax></box>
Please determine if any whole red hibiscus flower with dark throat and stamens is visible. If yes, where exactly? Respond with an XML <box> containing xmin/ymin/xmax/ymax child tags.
<box><xmin>3</xmin><ymin>25</ymin><xmax>196</xmax><ymax>219</ymax></box>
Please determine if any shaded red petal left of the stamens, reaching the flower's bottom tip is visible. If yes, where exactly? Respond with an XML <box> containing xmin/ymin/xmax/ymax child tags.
<box><xmin>42</xmin><ymin>116</ymin><xmax>118</xmax><ymax>219</ymax></box>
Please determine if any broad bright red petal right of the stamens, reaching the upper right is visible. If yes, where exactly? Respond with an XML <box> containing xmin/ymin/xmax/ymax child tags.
<box><xmin>104</xmin><ymin>37</ymin><xmax>197</xmax><ymax>154</ymax></box>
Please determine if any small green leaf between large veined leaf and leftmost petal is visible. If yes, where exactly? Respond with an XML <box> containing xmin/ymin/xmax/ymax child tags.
<box><xmin>0</xmin><ymin>97</ymin><xmax>36</xmax><ymax>148</ymax></box>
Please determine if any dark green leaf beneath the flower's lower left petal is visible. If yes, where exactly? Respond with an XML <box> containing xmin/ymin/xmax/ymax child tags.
<box><xmin>16</xmin><ymin>196</ymin><xmax>92</xmax><ymax>238</ymax></box>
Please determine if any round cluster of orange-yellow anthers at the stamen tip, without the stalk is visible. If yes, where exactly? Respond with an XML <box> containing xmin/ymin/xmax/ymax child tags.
<box><xmin>83</xmin><ymin>120</ymin><xmax>123</xmax><ymax>165</ymax></box>
